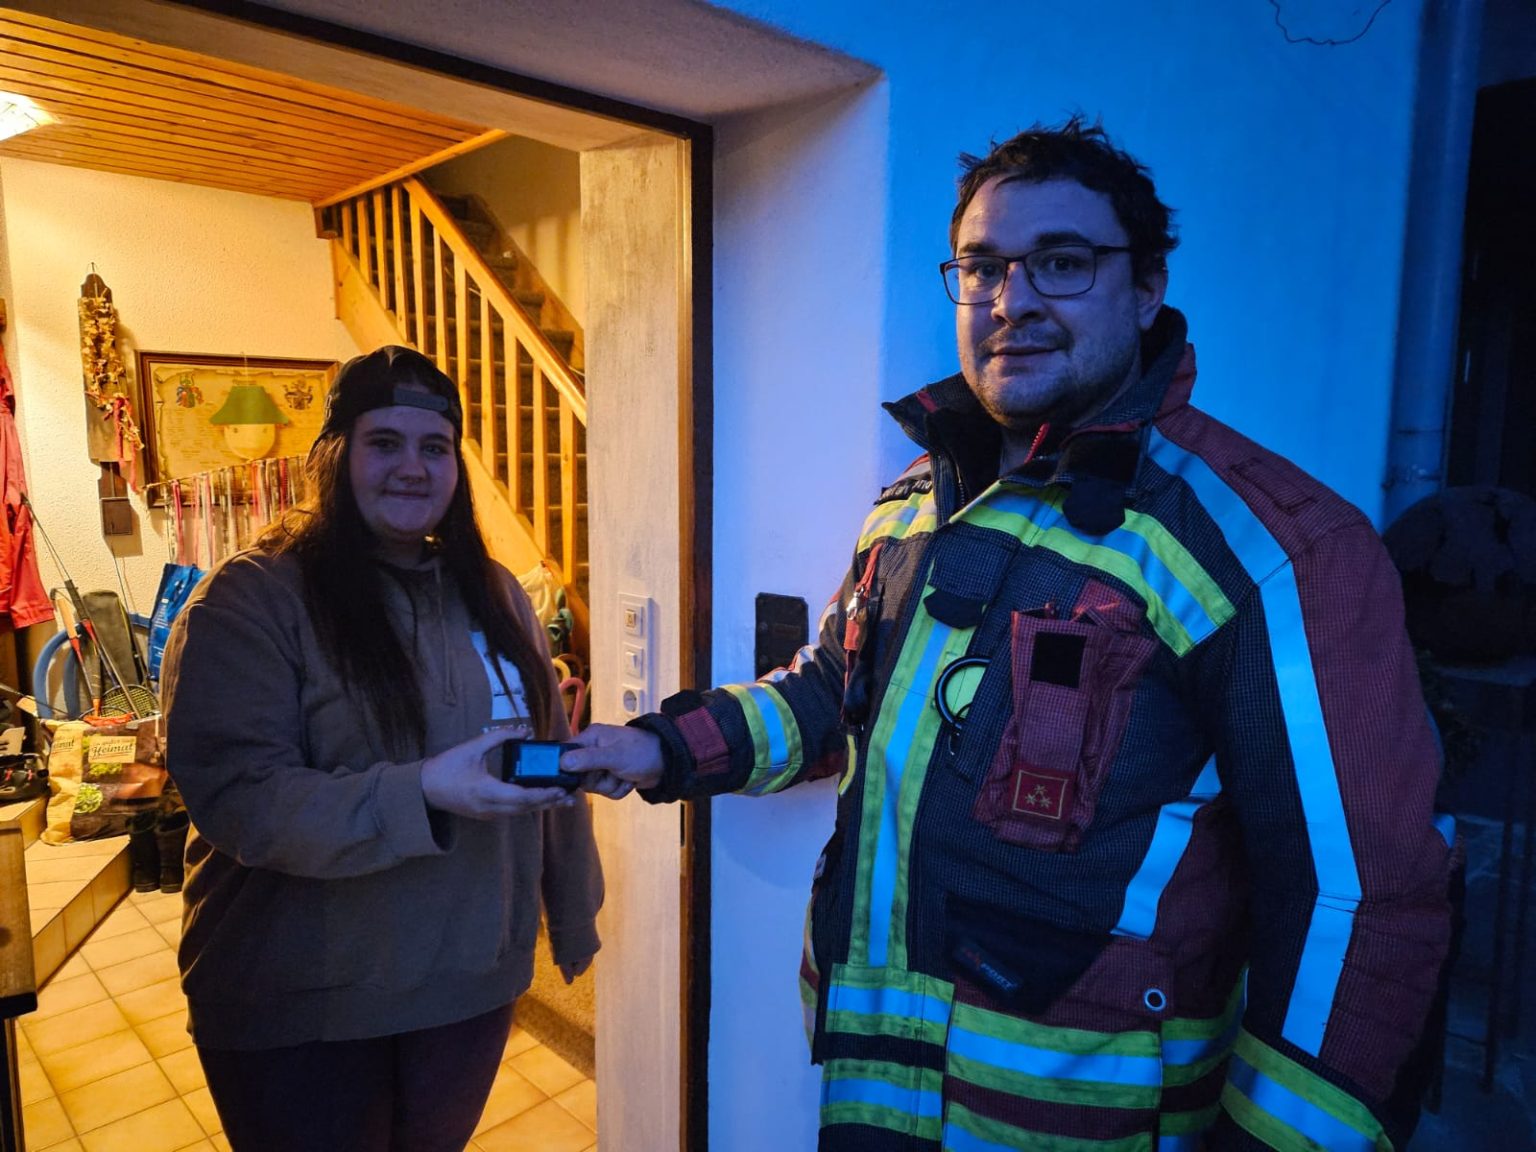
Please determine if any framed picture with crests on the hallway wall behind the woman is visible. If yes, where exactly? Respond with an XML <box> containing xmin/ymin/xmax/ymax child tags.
<box><xmin>138</xmin><ymin>352</ymin><xmax>336</xmax><ymax>504</ymax></box>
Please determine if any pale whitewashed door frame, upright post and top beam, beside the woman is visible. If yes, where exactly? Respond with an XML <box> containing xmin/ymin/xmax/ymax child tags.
<box><xmin>0</xmin><ymin>3</ymin><xmax>710</xmax><ymax>1152</ymax></box>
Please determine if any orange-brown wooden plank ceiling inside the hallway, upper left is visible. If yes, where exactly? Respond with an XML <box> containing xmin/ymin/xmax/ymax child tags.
<box><xmin>0</xmin><ymin>8</ymin><xmax>502</xmax><ymax>203</ymax></box>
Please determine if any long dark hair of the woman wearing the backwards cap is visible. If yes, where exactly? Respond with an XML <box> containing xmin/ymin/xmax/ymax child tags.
<box><xmin>258</xmin><ymin>349</ymin><xmax>550</xmax><ymax>756</ymax></box>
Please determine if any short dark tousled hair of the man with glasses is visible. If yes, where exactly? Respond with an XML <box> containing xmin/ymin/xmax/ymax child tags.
<box><xmin>949</xmin><ymin>115</ymin><xmax>1178</xmax><ymax>283</ymax></box>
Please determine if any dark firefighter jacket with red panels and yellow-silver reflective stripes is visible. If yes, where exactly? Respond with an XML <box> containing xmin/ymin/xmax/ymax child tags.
<box><xmin>639</xmin><ymin>309</ymin><xmax>1450</xmax><ymax>1152</ymax></box>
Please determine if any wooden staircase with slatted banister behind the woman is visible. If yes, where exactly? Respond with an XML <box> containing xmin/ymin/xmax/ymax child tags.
<box><xmin>319</xmin><ymin>178</ymin><xmax>590</xmax><ymax>656</ymax></box>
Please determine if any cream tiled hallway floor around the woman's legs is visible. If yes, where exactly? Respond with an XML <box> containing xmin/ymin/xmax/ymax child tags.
<box><xmin>17</xmin><ymin>892</ymin><xmax>598</xmax><ymax>1152</ymax></box>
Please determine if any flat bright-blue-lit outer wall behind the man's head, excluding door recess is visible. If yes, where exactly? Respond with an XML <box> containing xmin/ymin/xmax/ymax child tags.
<box><xmin>722</xmin><ymin>0</ymin><xmax>1421</xmax><ymax>513</ymax></box>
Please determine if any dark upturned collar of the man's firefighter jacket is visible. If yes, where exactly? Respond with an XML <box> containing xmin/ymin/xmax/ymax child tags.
<box><xmin>885</xmin><ymin>307</ymin><xmax>1195</xmax><ymax>536</ymax></box>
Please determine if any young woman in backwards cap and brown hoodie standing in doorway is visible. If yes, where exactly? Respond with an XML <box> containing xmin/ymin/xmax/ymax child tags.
<box><xmin>164</xmin><ymin>347</ymin><xmax>602</xmax><ymax>1152</ymax></box>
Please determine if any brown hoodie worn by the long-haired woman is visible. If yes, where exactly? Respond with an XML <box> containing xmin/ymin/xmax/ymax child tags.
<box><xmin>163</xmin><ymin>551</ymin><xmax>602</xmax><ymax>1049</ymax></box>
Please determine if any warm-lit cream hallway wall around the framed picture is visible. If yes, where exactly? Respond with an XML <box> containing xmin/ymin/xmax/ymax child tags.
<box><xmin>0</xmin><ymin>158</ymin><xmax>358</xmax><ymax>626</ymax></box>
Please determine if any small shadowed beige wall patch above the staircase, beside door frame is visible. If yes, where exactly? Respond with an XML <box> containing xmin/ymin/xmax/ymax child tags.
<box><xmin>422</xmin><ymin>137</ymin><xmax>587</xmax><ymax>326</ymax></box>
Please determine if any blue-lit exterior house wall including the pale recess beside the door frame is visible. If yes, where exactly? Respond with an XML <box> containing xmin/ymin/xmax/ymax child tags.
<box><xmin>697</xmin><ymin>0</ymin><xmax>1419</xmax><ymax>1152</ymax></box>
